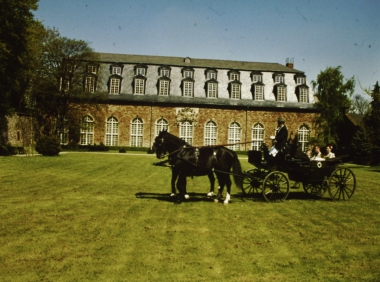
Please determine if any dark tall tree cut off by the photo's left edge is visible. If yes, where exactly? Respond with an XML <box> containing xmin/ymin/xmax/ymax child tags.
<box><xmin>0</xmin><ymin>0</ymin><xmax>38</xmax><ymax>145</ymax></box>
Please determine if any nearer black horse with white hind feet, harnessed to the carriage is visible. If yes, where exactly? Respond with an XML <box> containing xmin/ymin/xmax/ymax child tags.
<box><xmin>154</xmin><ymin>131</ymin><xmax>242</xmax><ymax>204</ymax></box>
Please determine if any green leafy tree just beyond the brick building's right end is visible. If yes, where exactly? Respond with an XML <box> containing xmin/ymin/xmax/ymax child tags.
<box><xmin>312</xmin><ymin>66</ymin><xmax>355</xmax><ymax>147</ymax></box>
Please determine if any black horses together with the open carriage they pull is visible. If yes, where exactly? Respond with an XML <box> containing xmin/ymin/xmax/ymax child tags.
<box><xmin>152</xmin><ymin>131</ymin><xmax>356</xmax><ymax>204</ymax></box>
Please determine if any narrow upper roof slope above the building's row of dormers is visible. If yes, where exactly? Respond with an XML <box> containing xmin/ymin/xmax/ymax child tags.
<box><xmin>97</xmin><ymin>53</ymin><xmax>304</xmax><ymax>74</ymax></box>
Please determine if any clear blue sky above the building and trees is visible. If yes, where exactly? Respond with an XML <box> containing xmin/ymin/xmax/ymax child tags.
<box><xmin>34</xmin><ymin>0</ymin><xmax>380</xmax><ymax>94</ymax></box>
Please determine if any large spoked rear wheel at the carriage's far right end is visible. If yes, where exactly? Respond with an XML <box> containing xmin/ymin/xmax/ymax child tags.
<box><xmin>328</xmin><ymin>168</ymin><xmax>356</xmax><ymax>200</ymax></box>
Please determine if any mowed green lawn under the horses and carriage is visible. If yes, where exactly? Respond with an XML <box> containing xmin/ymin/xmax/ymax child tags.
<box><xmin>0</xmin><ymin>153</ymin><xmax>380</xmax><ymax>281</ymax></box>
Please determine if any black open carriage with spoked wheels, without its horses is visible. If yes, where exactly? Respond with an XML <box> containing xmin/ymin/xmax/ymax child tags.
<box><xmin>242</xmin><ymin>146</ymin><xmax>356</xmax><ymax>202</ymax></box>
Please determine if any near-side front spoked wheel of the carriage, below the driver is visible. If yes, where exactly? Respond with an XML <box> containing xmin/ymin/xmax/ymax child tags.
<box><xmin>263</xmin><ymin>171</ymin><xmax>289</xmax><ymax>202</ymax></box>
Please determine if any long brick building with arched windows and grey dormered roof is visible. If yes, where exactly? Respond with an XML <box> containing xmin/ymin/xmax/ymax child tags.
<box><xmin>7</xmin><ymin>53</ymin><xmax>318</xmax><ymax>150</ymax></box>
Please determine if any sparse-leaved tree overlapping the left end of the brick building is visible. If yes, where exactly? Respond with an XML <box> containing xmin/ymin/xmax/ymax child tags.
<box><xmin>31</xmin><ymin>29</ymin><xmax>99</xmax><ymax>139</ymax></box>
